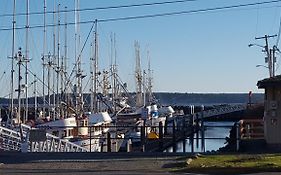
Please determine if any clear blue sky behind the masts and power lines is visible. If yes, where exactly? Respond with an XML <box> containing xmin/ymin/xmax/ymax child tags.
<box><xmin>0</xmin><ymin>0</ymin><xmax>281</xmax><ymax>96</ymax></box>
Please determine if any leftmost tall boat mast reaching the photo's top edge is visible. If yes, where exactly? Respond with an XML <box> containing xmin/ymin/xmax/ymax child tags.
<box><xmin>9</xmin><ymin>0</ymin><xmax>16</xmax><ymax>119</ymax></box>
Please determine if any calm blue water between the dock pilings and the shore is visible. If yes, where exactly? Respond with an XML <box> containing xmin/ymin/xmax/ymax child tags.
<box><xmin>167</xmin><ymin>122</ymin><xmax>234</xmax><ymax>152</ymax></box>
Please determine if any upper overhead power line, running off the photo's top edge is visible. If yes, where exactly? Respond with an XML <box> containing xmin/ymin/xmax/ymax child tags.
<box><xmin>0</xmin><ymin>0</ymin><xmax>199</xmax><ymax>17</ymax></box>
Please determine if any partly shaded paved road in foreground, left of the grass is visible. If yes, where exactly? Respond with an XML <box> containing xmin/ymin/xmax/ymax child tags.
<box><xmin>0</xmin><ymin>153</ymin><xmax>186</xmax><ymax>175</ymax></box>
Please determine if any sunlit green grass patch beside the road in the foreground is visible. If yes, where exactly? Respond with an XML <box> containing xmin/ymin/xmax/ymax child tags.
<box><xmin>167</xmin><ymin>154</ymin><xmax>281</xmax><ymax>174</ymax></box>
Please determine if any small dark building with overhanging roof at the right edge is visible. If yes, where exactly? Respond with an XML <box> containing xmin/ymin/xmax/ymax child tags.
<box><xmin>257</xmin><ymin>75</ymin><xmax>281</xmax><ymax>148</ymax></box>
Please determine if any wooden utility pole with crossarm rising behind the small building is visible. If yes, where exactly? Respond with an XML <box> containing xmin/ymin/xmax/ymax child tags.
<box><xmin>255</xmin><ymin>35</ymin><xmax>277</xmax><ymax>78</ymax></box>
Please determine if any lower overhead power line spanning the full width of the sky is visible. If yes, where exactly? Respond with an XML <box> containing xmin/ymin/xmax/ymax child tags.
<box><xmin>0</xmin><ymin>0</ymin><xmax>281</xmax><ymax>31</ymax></box>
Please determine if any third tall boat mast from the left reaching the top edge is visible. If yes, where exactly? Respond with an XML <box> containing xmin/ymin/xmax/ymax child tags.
<box><xmin>42</xmin><ymin>0</ymin><xmax>46</xmax><ymax>118</ymax></box>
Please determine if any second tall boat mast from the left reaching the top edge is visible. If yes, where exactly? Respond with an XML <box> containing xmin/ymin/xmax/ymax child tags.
<box><xmin>23</xmin><ymin>0</ymin><xmax>29</xmax><ymax>123</ymax></box>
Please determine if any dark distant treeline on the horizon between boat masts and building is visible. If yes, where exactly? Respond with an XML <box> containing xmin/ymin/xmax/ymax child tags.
<box><xmin>154</xmin><ymin>92</ymin><xmax>264</xmax><ymax>106</ymax></box>
